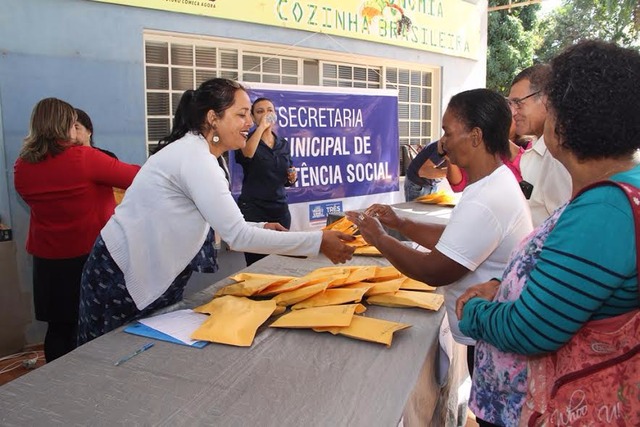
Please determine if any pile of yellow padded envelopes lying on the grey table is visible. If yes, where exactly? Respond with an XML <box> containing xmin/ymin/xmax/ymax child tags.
<box><xmin>191</xmin><ymin>265</ymin><xmax>444</xmax><ymax>347</ymax></box>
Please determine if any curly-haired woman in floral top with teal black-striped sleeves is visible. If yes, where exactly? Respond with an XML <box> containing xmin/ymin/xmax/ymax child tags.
<box><xmin>457</xmin><ymin>41</ymin><xmax>640</xmax><ymax>425</ymax></box>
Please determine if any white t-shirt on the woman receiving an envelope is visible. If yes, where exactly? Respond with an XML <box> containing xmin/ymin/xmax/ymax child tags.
<box><xmin>436</xmin><ymin>165</ymin><xmax>533</xmax><ymax>345</ymax></box>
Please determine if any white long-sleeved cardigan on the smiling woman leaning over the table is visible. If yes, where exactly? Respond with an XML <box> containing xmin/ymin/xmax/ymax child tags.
<box><xmin>100</xmin><ymin>133</ymin><xmax>322</xmax><ymax>309</ymax></box>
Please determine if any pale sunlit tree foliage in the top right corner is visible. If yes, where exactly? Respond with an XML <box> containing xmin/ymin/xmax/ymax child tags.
<box><xmin>535</xmin><ymin>0</ymin><xmax>640</xmax><ymax>62</ymax></box>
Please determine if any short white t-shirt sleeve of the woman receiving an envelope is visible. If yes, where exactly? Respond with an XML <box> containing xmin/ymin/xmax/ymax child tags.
<box><xmin>435</xmin><ymin>201</ymin><xmax>503</xmax><ymax>271</ymax></box>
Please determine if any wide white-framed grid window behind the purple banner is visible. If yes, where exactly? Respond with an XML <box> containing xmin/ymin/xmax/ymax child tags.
<box><xmin>145</xmin><ymin>32</ymin><xmax>439</xmax><ymax>171</ymax></box>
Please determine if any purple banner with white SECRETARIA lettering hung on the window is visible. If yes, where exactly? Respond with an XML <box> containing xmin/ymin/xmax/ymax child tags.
<box><xmin>229</xmin><ymin>86</ymin><xmax>399</xmax><ymax>203</ymax></box>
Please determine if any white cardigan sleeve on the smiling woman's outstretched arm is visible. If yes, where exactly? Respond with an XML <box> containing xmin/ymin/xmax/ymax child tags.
<box><xmin>180</xmin><ymin>156</ymin><xmax>322</xmax><ymax>256</ymax></box>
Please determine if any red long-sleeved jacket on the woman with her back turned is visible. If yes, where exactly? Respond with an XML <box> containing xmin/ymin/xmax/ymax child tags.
<box><xmin>14</xmin><ymin>146</ymin><xmax>140</xmax><ymax>259</ymax></box>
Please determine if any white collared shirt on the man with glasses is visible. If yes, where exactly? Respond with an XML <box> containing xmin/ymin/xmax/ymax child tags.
<box><xmin>520</xmin><ymin>137</ymin><xmax>571</xmax><ymax>227</ymax></box>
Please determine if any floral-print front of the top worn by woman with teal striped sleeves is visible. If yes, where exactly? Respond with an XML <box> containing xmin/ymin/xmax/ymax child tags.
<box><xmin>469</xmin><ymin>204</ymin><xmax>567</xmax><ymax>426</ymax></box>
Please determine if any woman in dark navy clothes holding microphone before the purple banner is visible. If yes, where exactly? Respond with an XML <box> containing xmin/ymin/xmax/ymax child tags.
<box><xmin>235</xmin><ymin>98</ymin><xmax>297</xmax><ymax>265</ymax></box>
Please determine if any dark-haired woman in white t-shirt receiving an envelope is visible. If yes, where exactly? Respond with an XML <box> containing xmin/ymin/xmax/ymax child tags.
<box><xmin>347</xmin><ymin>89</ymin><xmax>532</xmax><ymax>372</ymax></box>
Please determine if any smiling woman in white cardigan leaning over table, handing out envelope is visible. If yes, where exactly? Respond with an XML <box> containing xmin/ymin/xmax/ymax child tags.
<box><xmin>79</xmin><ymin>78</ymin><xmax>353</xmax><ymax>343</ymax></box>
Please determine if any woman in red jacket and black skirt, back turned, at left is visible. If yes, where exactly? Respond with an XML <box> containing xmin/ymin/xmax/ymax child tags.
<box><xmin>14</xmin><ymin>98</ymin><xmax>140</xmax><ymax>362</ymax></box>
